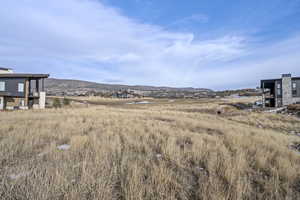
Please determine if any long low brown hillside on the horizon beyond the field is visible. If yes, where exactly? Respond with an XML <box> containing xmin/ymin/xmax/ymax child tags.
<box><xmin>45</xmin><ymin>78</ymin><xmax>215</xmax><ymax>98</ymax></box>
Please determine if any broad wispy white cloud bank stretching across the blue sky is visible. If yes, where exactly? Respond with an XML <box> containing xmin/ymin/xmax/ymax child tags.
<box><xmin>0</xmin><ymin>0</ymin><xmax>300</xmax><ymax>88</ymax></box>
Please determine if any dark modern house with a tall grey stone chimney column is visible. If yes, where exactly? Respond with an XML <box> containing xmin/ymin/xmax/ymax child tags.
<box><xmin>261</xmin><ymin>74</ymin><xmax>300</xmax><ymax>107</ymax></box>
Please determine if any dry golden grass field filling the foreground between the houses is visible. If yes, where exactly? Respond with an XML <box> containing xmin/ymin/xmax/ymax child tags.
<box><xmin>0</xmin><ymin>96</ymin><xmax>300</xmax><ymax>200</ymax></box>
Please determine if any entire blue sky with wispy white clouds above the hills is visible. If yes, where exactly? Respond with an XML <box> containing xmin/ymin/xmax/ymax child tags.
<box><xmin>0</xmin><ymin>0</ymin><xmax>300</xmax><ymax>90</ymax></box>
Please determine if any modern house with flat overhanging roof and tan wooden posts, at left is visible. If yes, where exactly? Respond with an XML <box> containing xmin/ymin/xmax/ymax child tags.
<box><xmin>0</xmin><ymin>68</ymin><xmax>49</xmax><ymax>110</ymax></box>
